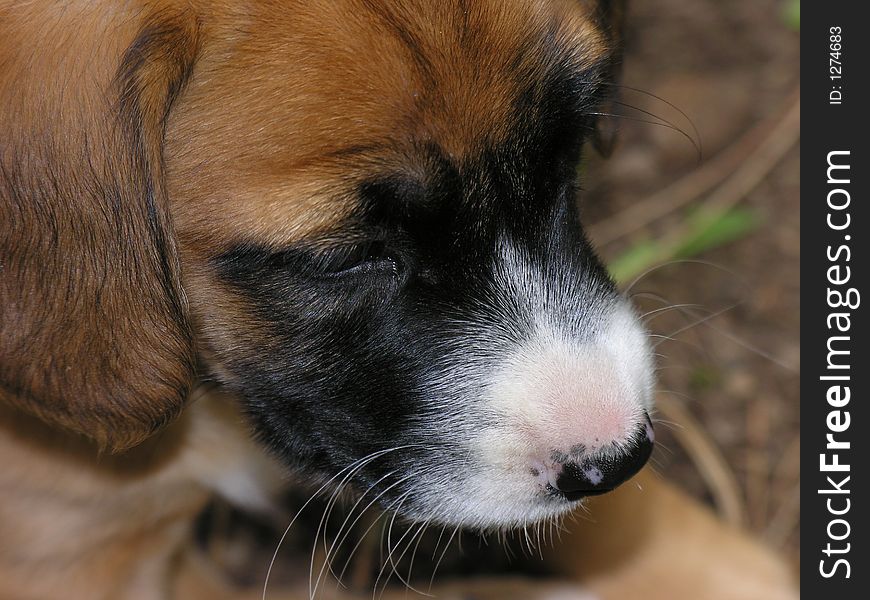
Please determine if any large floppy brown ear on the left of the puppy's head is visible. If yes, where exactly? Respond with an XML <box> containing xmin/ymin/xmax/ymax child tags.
<box><xmin>0</xmin><ymin>8</ymin><xmax>199</xmax><ymax>451</ymax></box>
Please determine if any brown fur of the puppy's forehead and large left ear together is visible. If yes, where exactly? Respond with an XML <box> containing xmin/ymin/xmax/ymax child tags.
<box><xmin>0</xmin><ymin>0</ymin><xmax>608</xmax><ymax>450</ymax></box>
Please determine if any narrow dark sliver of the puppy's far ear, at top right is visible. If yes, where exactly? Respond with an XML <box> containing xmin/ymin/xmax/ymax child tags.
<box><xmin>592</xmin><ymin>0</ymin><xmax>628</xmax><ymax>158</ymax></box>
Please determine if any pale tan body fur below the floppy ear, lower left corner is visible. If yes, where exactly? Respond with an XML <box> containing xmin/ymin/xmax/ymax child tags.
<box><xmin>0</xmin><ymin>395</ymin><xmax>280</xmax><ymax>600</ymax></box>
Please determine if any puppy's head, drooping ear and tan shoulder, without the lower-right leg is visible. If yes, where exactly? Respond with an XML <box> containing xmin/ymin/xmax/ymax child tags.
<box><xmin>0</xmin><ymin>0</ymin><xmax>796</xmax><ymax>598</ymax></box>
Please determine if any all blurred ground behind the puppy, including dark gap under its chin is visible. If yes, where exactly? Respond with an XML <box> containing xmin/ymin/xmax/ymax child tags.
<box><xmin>200</xmin><ymin>0</ymin><xmax>800</xmax><ymax>593</ymax></box>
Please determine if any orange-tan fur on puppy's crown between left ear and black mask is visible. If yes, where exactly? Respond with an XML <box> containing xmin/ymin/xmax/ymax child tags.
<box><xmin>166</xmin><ymin>0</ymin><xmax>605</xmax><ymax>253</ymax></box>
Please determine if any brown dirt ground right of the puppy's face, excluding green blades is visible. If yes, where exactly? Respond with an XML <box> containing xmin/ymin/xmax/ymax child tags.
<box><xmin>583</xmin><ymin>0</ymin><xmax>800</xmax><ymax>565</ymax></box>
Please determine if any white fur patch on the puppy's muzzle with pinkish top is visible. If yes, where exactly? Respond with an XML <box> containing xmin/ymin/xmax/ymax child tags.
<box><xmin>412</xmin><ymin>244</ymin><xmax>653</xmax><ymax>528</ymax></box>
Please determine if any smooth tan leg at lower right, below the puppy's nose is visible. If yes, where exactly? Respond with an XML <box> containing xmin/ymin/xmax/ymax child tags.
<box><xmin>546</xmin><ymin>468</ymin><xmax>798</xmax><ymax>600</ymax></box>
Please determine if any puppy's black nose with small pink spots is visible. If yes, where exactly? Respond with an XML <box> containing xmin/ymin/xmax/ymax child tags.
<box><xmin>556</xmin><ymin>417</ymin><xmax>654</xmax><ymax>500</ymax></box>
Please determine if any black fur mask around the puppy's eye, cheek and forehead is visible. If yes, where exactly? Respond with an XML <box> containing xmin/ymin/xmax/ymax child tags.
<box><xmin>204</xmin><ymin>42</ymin><xmax>640</xmax><ymax>514</ymax></box>
